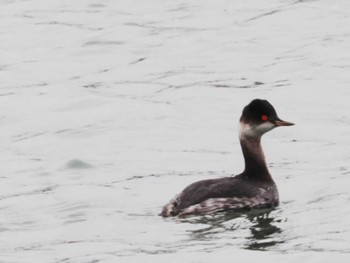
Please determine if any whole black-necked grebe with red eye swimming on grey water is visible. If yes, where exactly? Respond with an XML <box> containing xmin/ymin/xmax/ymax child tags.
<box><xmin>160</xmin><ymin>99</ymin><xmax>294</xmax><ymax>217</ymax></box>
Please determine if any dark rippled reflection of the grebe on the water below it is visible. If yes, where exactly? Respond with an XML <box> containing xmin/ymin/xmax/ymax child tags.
<box><xmin>181</xmin><ymin>209</ymin><xmax>284</xmax><ymax>250</ymax></box>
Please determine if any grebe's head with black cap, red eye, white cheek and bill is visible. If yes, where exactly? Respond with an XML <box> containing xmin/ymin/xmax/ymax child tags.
<box><xmin>240</xmin><ymin>99</ymin><xmax>294</xmax><ymax>136</ymax></box>
